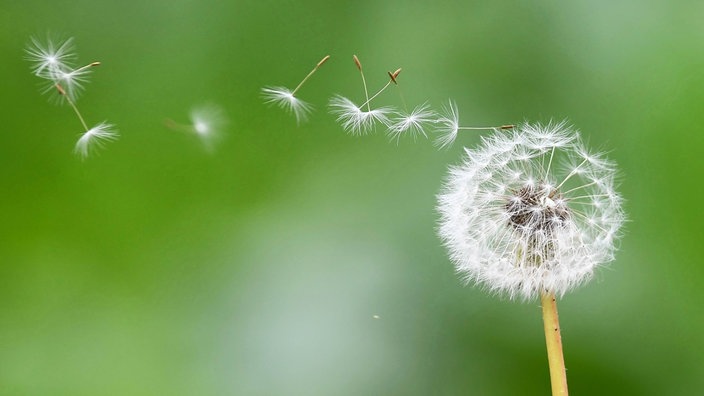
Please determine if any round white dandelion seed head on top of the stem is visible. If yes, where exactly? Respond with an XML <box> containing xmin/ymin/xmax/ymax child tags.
<box><xmin>438</xmin><ymin>122</ymin><xmax>625</xmax><ymax>300</ymax></box>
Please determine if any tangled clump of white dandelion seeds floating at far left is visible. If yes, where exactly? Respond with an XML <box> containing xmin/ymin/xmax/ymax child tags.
<box><xmin>26</xmin><ymin>34</ymin><xmax>118</xmax><ymax>159</ymax></box>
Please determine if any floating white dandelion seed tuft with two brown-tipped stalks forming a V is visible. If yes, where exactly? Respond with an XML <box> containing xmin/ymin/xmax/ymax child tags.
<box><xmin>329</xmin><ymin>55</ymin><xmax>401</xmax><ymax>135</ymax></box>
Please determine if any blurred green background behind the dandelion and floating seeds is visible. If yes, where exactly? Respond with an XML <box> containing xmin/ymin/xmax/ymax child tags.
<box><xmin>0</xmin><ymin>0</ymin><xmax>704</xmax><ymax>396</ymax></box>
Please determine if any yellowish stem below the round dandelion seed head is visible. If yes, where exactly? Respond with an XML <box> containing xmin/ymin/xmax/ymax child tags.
<box><xmin>540</xmin><ymin>292</ymin><xmax>567</xmax><ymax>396</ymax></box>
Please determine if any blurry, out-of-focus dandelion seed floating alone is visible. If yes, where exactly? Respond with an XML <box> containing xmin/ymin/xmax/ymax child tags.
<box><xmin>166</xmin><ymin>103</ymin><xmax>228</xmax><ymax>151</ymax></box>
